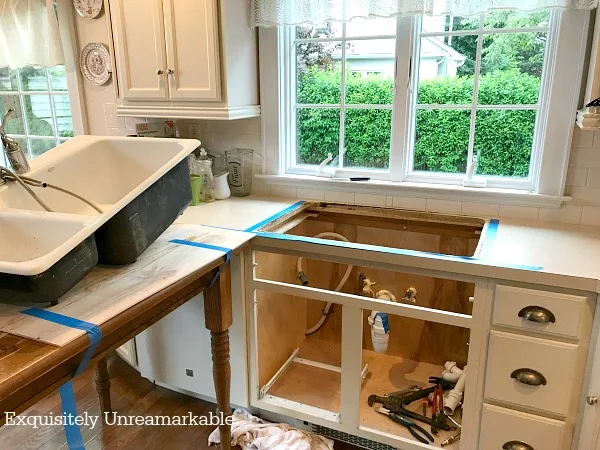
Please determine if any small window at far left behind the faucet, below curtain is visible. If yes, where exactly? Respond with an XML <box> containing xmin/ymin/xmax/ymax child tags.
<box><xmin>0</xmin><ymin>66</ymin><xmax>74</xmax><ymax>165</ymax></box>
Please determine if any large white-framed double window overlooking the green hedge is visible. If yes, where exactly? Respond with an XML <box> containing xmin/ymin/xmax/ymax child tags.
<box><xmin>270</xmin><ymin>10</ymin><xmax>588</xmax><ymax>196</ymax></box>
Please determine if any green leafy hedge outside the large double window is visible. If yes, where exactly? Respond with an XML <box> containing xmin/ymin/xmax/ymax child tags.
<box><xmin>297</xmin><ymin>70</ymin><xmax>540</xmax><ymax>177</ymax></box>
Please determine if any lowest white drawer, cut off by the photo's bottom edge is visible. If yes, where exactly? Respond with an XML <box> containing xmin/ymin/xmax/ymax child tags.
<box><xmin>478</xmin><ymin>405</ymin><xmax>568</xmax><ymax>450</ymax></box>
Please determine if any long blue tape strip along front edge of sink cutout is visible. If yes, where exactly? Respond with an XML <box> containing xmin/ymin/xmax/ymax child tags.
<box><xmin>256</xmin><ymin>231</ymin><xmax>543</xmax><ymax>271</ymax></box>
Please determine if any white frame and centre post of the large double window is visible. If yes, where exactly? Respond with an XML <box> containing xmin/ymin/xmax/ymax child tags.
<box><xmin>259</xmin><ymin>11</ymin><xmax>590</xmax><ymax>196</ymax></box>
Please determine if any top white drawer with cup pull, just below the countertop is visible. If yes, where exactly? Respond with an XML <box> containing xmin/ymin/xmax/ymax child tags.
<box><xmin>492</xmin><ymin>285</ymin><xmax>593</xmax><ymax>340</ymax></box>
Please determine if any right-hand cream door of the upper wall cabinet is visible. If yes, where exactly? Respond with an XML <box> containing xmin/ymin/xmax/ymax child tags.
<box><xmin>163</xmin><ymin>0</ymin><xmax>221</xmax><ymax>101</ymax></box>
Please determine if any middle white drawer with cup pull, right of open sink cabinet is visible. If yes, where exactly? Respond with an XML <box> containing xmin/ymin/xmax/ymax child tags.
<box><xmin>485</xmin><ymin>331</ymin><xmax>581</xmax><ymax>416</ymax></box>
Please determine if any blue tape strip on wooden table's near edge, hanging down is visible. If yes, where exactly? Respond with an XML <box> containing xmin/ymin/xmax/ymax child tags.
<box><xmin>21</xmin><ymin>308</ymin><xmax>102</xmax><ymax>450</ymax></box>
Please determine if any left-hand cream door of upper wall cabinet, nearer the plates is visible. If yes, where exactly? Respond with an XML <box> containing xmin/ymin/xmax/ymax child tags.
<box><xmin>110</xmin><ymin>0</ymin><xmax>168</xmax><ymax>100</ymax></box>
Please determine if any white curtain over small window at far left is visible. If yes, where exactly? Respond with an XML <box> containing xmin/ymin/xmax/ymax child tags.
<box><xmin>0</xmin><ymin>0</ymin><xmax>64</xmax><ymax>69</ymax></box>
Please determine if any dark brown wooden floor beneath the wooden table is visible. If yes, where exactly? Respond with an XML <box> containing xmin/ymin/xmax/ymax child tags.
<box><xmin>0</xmin><ymin>355</ymin><xmax>358</xmax><ymax>450</ymax></box>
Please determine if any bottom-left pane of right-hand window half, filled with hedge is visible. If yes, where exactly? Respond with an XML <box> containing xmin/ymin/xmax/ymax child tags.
<box><xmin>413</xmin><ymin>109</ymin><xmax>470</xmax><ymax>173</ymax></box>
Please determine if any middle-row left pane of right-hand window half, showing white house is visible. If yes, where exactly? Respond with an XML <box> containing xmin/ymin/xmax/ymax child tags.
<box><xmin>417</xmin><ymin>36</ymin><xmax>477</xmax><ymax>105</ymax></box>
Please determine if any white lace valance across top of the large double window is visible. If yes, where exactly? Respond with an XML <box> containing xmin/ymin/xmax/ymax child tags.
<box><xmin>252</xmin><ymin>0</ymin><xmax>598</xmax><ymax>27</ymax></box>
